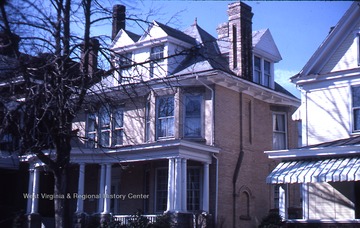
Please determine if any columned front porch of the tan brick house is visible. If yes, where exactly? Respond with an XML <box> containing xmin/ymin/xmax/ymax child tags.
<box><xmin>22</xmin><ymin>140</ymin><xmax>219</xmax><ymax>227</ymax></box>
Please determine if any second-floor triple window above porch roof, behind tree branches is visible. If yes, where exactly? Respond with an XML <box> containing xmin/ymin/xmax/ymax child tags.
<box><xmin>86</xmin><ymin>105</ymin><xmax>124</xmax><ymax>148</ymax></box>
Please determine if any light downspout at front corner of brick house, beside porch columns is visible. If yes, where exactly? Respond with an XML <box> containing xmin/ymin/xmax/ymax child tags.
<box><xmin>196</xmin><ymin>75</ymin><xmax>219</xmax><ymax>224</ymax></box>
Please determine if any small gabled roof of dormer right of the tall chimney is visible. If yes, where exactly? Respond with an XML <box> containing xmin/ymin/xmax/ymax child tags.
<box><xmin>252</xmin><ymin>29</ymin><xmax>282</xmax><ymax>62</ymax></box>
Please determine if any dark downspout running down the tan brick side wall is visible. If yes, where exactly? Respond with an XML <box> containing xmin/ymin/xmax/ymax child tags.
<box><xmin>232</xmin><ymin>93</ymin><xmax>244</xmax><ymax>228</ymax></box>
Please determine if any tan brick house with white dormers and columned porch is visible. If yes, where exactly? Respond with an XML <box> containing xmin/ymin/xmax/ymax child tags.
<box><xmin>20</xmin><ymin>2</ymin><xmax>300</xmax><ymax>227</ymax></box>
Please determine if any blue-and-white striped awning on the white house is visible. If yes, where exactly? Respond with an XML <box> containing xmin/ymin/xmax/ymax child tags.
<box><xmin>266</xmin><ymin>157</ymin><xmax>360</xmax><ymax>184</ymax></box>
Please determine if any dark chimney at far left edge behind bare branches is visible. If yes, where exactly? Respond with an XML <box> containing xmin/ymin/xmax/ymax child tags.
<box><xmin>0</xmin><ymin>32</ymin><xmax>20</xmax><ymax>57</ymax></box>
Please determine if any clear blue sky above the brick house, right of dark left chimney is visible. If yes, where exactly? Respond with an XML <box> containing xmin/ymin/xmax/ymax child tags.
<box><xmin>116</xmin><ymin>0</ymin><xmax>352</xmax><ymax>96</ymax></box>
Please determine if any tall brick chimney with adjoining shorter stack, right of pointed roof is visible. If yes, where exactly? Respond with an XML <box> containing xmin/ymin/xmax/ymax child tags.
<box><xmin>217</xmin><ymin>2</ymin><xmax>253</xmax><ymax>80</ymax></box>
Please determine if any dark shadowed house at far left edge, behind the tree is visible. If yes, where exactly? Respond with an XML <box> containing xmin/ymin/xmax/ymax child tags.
<box><xmin>0</xmin><ymin>32</ymin><xmax>27</xmax><ymax>227</ymax></box>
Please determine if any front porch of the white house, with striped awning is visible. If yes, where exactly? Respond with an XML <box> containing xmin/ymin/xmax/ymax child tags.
<box><xmin>266</xmin><ymin>140</ymin><xmax>360</xmax><ymax>227</ymax></box>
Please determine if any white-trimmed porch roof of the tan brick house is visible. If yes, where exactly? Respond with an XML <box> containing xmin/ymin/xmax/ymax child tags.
<box><xmin>21</xmin><ymin>140</ymin><xmax>220</xmax><ymax>165</ymax></box>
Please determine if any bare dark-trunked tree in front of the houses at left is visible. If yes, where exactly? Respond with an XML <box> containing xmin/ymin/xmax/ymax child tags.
<box><xmin>0</xmin><ymin>0</ymin><xmax>113</xmax><ymax>227</ymax></box>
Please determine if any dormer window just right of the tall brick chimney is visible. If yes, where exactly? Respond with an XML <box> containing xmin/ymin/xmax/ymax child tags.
<box><xmin>253</xmin><ymin>56</ymin><xmax>272</xmax><ymax>88</ymax></box>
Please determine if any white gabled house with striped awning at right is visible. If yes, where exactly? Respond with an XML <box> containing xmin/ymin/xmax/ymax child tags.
<box><xmin>266</xmin><ymin>2</ymin><xmax>360</xmax><ymax>227</ymax></box>
